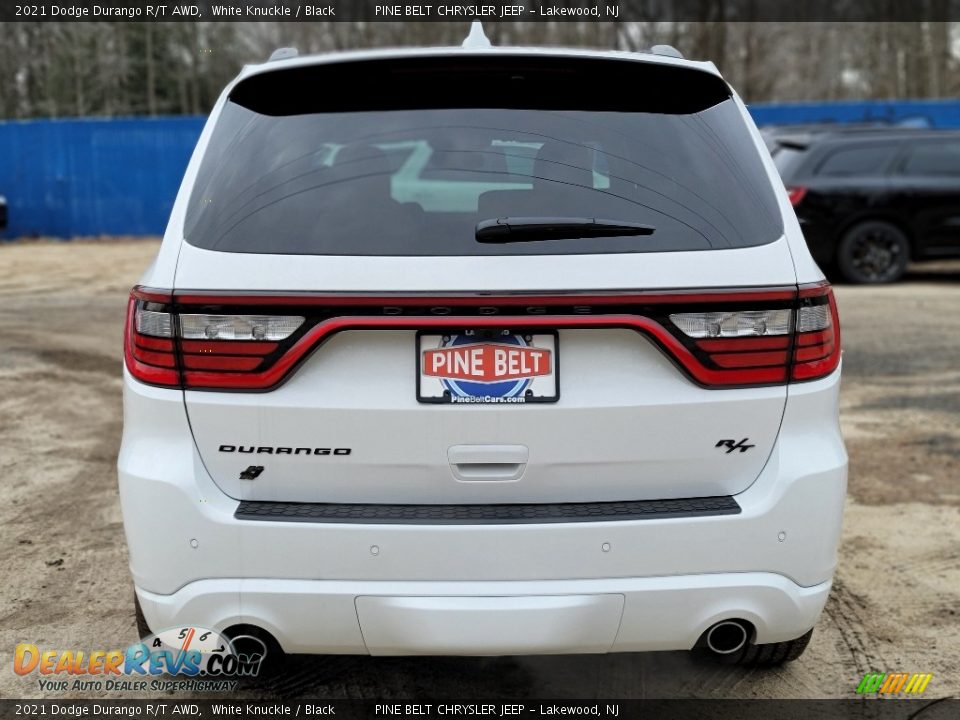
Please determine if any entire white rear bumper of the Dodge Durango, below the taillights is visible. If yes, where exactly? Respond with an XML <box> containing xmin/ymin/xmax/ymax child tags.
<box><xmin>118</xmin><ymin>371</ymin><xmax>847</xmax><ymax>654</ymax></box>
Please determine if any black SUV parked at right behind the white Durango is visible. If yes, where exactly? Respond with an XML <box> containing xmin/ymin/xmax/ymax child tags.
<box><xmin>773</xmin><ymin>129</ymin><xmax>960</xmax><ymax>283</ymax></box>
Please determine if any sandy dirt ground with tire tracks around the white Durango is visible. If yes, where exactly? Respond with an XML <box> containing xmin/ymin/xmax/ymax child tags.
<box><xmin>0</xmin><ymin>241</ymin><xmax>960</xmax><ymax>698</ymax></box>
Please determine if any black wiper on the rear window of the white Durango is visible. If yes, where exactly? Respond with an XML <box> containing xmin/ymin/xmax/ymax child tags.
<box><xmin>476</xmin><ymin>217</ymin><xmax>656</xmax><ymax>243</ymax></box>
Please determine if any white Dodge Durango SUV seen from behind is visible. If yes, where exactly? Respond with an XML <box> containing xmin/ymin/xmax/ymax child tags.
<box><xmin>119</xmin><ymin>38</ymin><xmax>847</xmax><ymax>664</ymax></box>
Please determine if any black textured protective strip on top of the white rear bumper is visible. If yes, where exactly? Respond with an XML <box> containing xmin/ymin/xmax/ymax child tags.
<box><xmin>234</xmin><ymin>495</ymin><xmax>740</xmax><ymax>525</ymax></box>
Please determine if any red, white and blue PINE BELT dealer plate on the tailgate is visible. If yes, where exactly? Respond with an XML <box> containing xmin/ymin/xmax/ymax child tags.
<box><xmin>417</xmin><ymin>328</ymin><xmax>560</xmax><ymax>405</ymax></box>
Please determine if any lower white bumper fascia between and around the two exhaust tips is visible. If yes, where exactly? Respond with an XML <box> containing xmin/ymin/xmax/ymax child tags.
<box><xmin>137</xmin><ymin>573</ymin><xmax>830</xmax><ymax>655</ymax></box>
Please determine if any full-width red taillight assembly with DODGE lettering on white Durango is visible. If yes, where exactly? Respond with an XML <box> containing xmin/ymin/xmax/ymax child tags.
<box><xmin>124</xmin><ymin>283</ymin><xmax>840</xmax><ymax>391</ymax></box>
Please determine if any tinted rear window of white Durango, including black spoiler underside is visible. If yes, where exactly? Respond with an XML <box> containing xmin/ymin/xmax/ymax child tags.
<box><xmin>185</xmin><ymin>56</ymin><xmax>782</xmax><ymax>256</ymax></box>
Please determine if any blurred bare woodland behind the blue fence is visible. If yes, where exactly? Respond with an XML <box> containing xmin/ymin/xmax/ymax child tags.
<box><xmin>0</xmin><ymin>20</ymin><xmax>960</xmax><ymax>118</ymax></box>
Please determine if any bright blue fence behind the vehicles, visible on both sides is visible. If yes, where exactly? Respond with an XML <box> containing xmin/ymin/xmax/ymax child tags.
<box><xmin>0</xmin><ymin>100</ymin><xmax>960</xmax><ymax>238</ymax></box>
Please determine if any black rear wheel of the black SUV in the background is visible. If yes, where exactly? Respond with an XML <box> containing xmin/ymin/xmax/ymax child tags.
<box><xmin>837</xmin><ymin>220</ymin><xmax>910</xmax><ymax>283</ymax></box>
